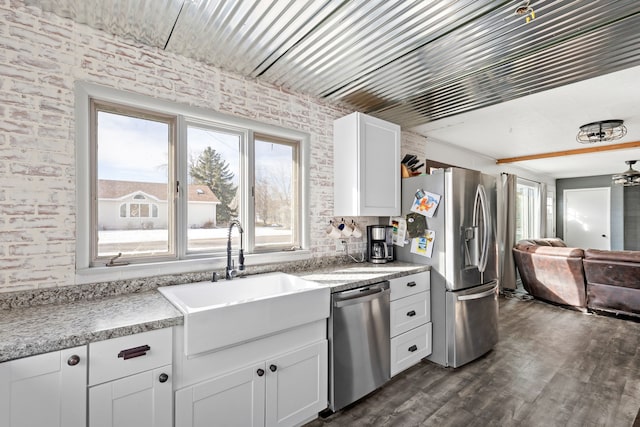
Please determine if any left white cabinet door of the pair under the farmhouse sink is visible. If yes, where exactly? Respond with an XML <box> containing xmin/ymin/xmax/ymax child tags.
<box><xmin>175</xmin><ymin>363</ymin><xmax>266</xmax><ymax>427</ymax></box>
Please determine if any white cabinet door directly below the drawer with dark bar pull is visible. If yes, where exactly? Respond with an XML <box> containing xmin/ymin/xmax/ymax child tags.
<box><xmin>89</xmin><ymin>365</ymin><xmax>173</xmax><ymax>427</ymax></box>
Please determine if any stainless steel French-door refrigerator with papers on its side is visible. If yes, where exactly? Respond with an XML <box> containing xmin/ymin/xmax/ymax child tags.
<box><xmin>396</xmin><ymin>168</ymin><xmax>498</xmax><ymax>368</ymax></box>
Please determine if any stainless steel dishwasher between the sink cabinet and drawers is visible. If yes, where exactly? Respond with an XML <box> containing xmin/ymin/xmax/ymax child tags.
<box><xmin>328</xmin><ymin>281</ymin><xmax>391</xmax><ymax>412</ymax></box>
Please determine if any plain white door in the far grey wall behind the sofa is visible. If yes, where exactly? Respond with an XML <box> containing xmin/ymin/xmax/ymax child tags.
<box><xmin>563</xmin><ymin>187</ymin><xmax>611</xmax><ymax>250</ymax></box>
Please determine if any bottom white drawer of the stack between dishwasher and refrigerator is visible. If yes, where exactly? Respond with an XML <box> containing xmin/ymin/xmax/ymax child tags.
<box><xmin>391</xmin><ymin>322</ymin><xmax>431</xmax><ymax>376</ymax></box>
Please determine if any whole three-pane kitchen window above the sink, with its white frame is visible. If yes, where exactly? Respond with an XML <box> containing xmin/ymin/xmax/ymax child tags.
<box><xmin>76</xmin><ymin>84</ymin><xmax>309</xmax><ymax>282</ymax></box>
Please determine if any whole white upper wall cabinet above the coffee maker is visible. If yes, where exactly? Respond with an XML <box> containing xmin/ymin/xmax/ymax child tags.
<box><xmin>333</xmin><ymin>113</ymin><xmax>401</xmax><ymax>216</ymax></box>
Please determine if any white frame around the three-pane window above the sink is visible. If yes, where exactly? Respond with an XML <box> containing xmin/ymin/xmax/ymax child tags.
<box><xmin>75</xmin><ymin>82</ymin><xmax>311</xmax><ymax>284</ymax></box>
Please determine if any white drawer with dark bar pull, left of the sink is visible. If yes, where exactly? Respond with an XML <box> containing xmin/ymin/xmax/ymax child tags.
<box><xmin>89</xmin><ymin>328</ymin><xmax>172</xmax><ymax>386</ymax></box>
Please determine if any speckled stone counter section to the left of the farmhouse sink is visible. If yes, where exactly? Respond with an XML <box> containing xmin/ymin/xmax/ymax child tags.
<box><xmin>0</xmin><ymin>290</ymin><xmax>183</xmax><ymax>362</ymax></box>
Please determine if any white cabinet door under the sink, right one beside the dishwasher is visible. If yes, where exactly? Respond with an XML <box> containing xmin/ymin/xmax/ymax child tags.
<box><xmin>266</xmin><ymin>340</ymin><xmax>328</xmax><ymax>426</ymax></box>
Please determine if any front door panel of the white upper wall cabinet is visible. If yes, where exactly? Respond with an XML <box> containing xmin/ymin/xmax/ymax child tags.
<box><xmin>360</xmin><ymin>115</ymin><xmax>400</xmax><ymax>216</ymax></box>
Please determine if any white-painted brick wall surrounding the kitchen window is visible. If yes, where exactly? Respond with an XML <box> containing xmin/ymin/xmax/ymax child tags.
<box><xmin>0</xmin><ymin>0</ymin><xmax>420</xmax><ymax>292</ymax></box>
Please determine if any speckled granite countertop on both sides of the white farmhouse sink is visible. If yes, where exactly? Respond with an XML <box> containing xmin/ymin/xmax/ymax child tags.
<box><xmin>0</xmin><ymin>262</ymin><xmax>430</xmax><ymax>362</ymax></box>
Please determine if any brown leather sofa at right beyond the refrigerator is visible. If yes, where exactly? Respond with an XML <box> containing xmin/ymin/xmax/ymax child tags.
<box><xmin>513</xmin><ymin>238</ymin><xmax>640</xmax><ymax>317</ymax></box>
